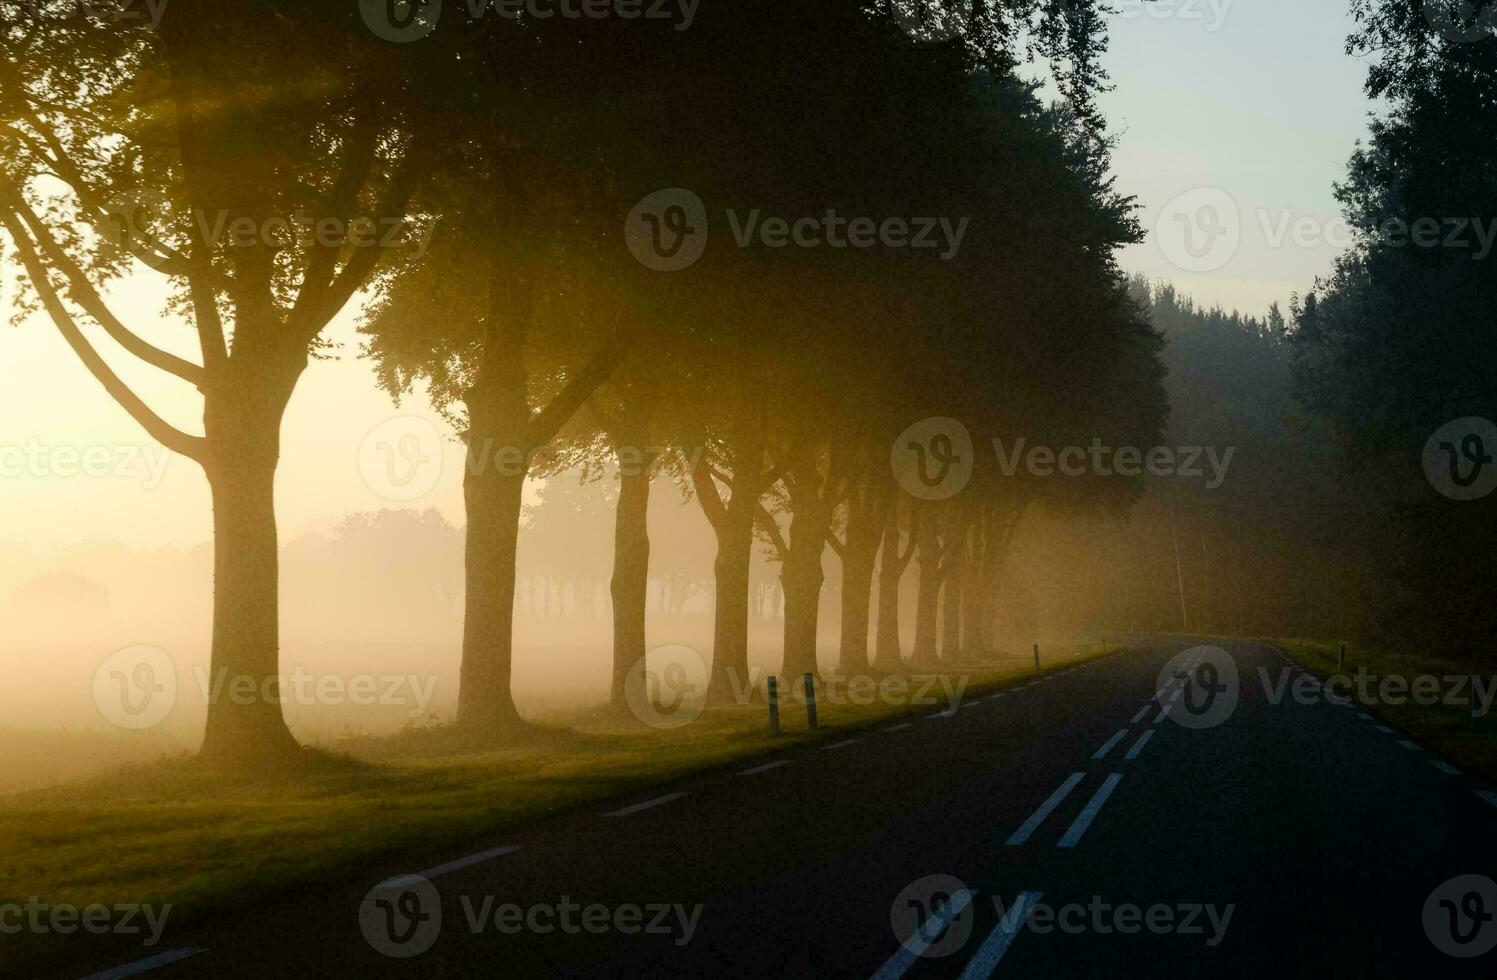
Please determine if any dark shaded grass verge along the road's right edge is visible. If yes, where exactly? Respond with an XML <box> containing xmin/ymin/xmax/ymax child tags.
<box><xmin>1263</xmin><ymin>637</ymin><xmax>1497</xmax><ymax>780</ymax></box>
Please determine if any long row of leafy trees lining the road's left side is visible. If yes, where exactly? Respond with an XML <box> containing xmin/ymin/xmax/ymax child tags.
<box><xmin>0</xmin><ymin>0</ymin><xmax>1165</xmax><ymax>763</ymax></box>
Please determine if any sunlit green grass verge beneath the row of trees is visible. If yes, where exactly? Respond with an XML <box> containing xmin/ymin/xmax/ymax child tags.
<box><xmin>0</xmin><ymin>643</ymin><xmax>1120</xmax><ymax>970</ymax></box>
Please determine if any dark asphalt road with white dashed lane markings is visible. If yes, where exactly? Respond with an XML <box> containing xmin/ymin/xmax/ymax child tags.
<box><xmin>75</xmin><ymin>637</ymin><xmax>1497</xmax><ymax>980</ymax></box>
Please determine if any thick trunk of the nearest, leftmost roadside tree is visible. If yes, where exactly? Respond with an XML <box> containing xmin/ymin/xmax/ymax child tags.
<box><xmin>201</xmin><ymin>383</ymin><xmax>304</xmax><ymax>768</ymax></box>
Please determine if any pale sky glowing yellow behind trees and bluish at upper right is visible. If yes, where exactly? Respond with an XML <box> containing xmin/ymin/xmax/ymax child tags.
<box><xmin>0</xmin><ymin>0</ymin><xmax>1368</xmax><ymax>551</ymax></box>
